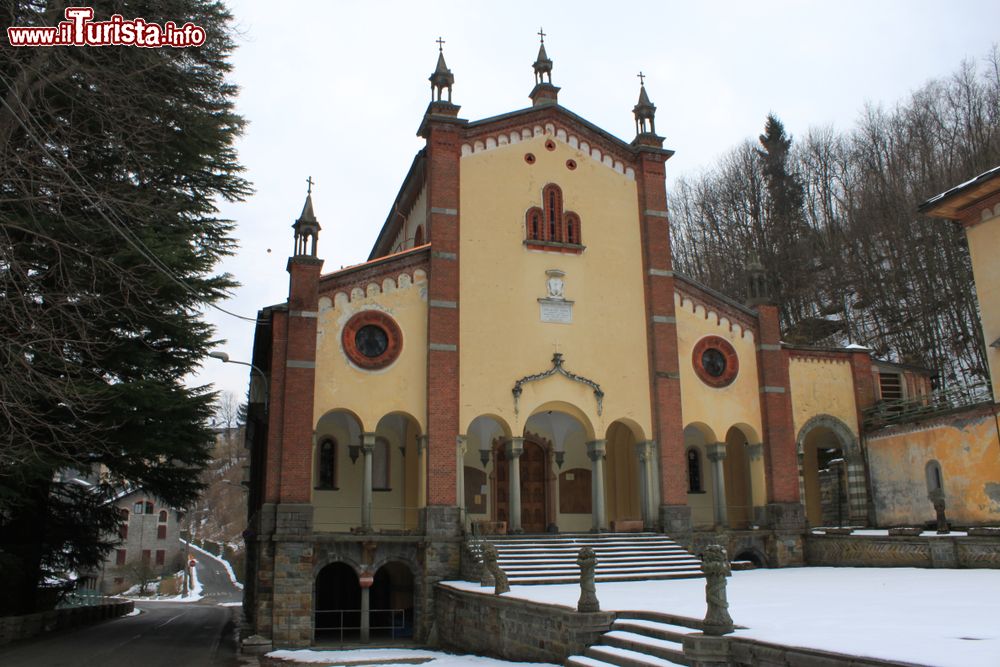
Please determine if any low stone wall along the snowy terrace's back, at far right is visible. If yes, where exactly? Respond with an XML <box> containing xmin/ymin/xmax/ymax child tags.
<box><xmin>805</xmin><ymin>534</ymin><xmax>1000</xmax><ymax>568</ymax></box>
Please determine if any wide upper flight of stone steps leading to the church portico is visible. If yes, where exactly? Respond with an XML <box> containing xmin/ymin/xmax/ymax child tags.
<box><xmin>473</xmin><ymin>533</ymin><xmax>702</xmax><ymax>584</ymax></box>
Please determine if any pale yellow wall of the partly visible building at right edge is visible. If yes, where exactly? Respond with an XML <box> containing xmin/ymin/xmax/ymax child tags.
<box><xmin>966</xmin><ymin>217</ymin><xmax>1000</xmax><ymax>400</ymax></box>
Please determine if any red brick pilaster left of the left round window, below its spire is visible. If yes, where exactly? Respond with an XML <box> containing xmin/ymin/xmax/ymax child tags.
<box><xmin>274</xmin><ymin>256</ymin><xmax>323</xmax><ymax>503</ymax></box>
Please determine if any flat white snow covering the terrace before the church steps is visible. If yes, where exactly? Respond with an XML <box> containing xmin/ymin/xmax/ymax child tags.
<box><xmin>446</xmin><ymin>567</ymin><xmax>1000</xmax><ymax>667</ymax></box>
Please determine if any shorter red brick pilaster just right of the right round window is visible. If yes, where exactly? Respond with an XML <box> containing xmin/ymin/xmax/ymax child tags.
<box><xmin>757</xmin><ymin>304</ymin><xmax>799</xmax><ymax>503</ymax></box>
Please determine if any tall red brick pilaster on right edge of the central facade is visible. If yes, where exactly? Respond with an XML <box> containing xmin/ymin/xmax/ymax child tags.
<box><xmin>636</xmin><ymin>147</ymin><xmax>687</xmax><ymax>505</ymax></box>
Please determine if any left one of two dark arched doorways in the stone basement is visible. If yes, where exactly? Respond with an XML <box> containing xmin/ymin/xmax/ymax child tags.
<box><xmin>313</xmin><ymin>561</ymin><xmax>361</xmax><ymax>644</ymax></box>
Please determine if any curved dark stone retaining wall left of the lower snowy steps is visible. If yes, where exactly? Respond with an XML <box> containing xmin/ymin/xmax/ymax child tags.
<box><xmin>434</xmin><ymin>585</ymin><xmax>615</xmax><ymax>664</ymax></box>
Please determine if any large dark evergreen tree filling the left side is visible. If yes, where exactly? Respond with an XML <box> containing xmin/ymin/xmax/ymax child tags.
<box><xmin>0</xmin><ymin>0</ymin><xmax>250</xmax><ymax>614</ymax></box>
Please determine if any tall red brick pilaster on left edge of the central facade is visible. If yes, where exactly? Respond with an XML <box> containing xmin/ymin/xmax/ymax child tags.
<box><xmin>421</xmin><ymin>115</ymin><xmax>463</xmax><ymax>507</ymax></box>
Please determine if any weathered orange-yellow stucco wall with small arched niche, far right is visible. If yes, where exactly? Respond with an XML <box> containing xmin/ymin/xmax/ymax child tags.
<box><xmin>866</xmin><ymin>410</ymin><xmax>1000</xmax><ymax>526</ymax></box>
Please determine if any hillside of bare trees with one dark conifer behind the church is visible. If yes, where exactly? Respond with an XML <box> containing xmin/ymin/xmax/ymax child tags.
<box><xmin>669</xmin><ymin>48</ymin><xmax>1000</xmax><ymax>394</ymax></box>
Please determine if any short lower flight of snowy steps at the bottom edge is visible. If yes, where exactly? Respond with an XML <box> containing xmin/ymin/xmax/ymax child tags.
<box><xmin>565</xmin><ymin>612</ymin><xmax>701</xmax><ymax>667</ymax></box>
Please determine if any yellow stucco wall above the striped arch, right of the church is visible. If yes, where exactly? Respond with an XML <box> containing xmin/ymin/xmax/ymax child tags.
<box><xmin>788</xmin><ymin>356</ymin><xmax>858</xmax><ymax>437</ymax></box>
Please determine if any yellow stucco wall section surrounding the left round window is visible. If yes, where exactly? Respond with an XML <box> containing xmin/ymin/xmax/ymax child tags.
<box><xmin>313</xmin><ymin>270</ymin><xmax>427</xmax><ymax>431</ymax></box>
